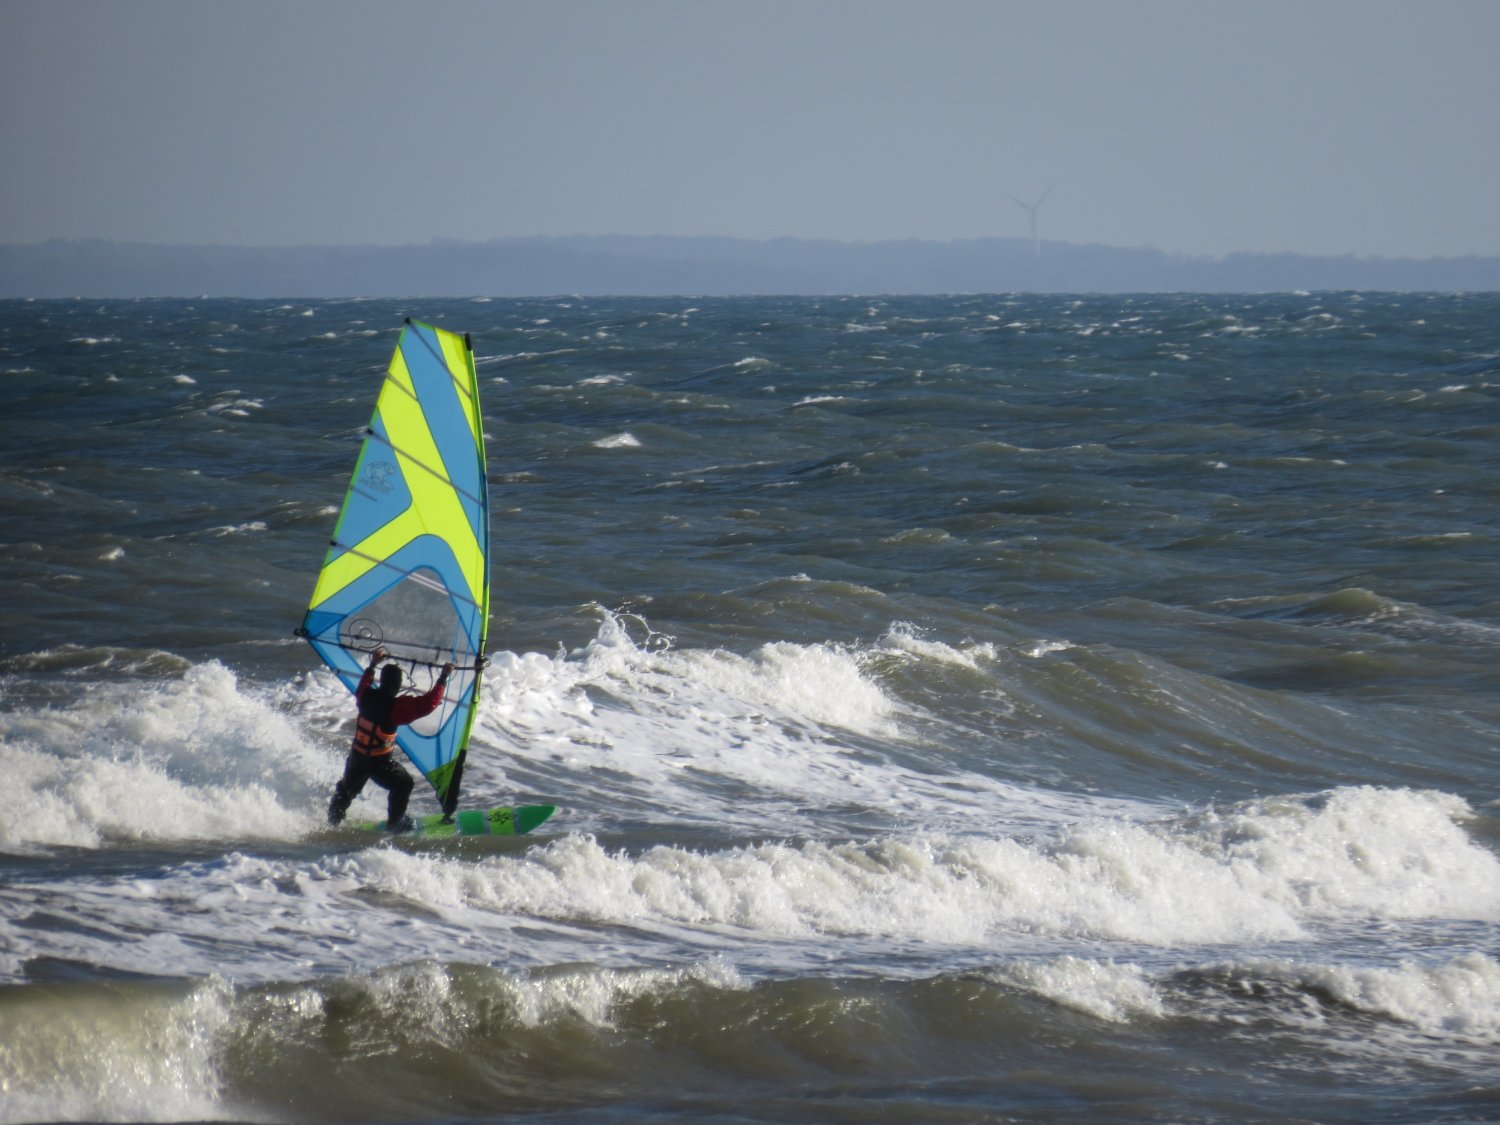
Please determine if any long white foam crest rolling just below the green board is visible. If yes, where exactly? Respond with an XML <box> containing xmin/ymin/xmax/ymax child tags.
<box><xmin>252</xmin><ymin>791</ymin><xmax>1500</xmax><ymax>966</ymax></box>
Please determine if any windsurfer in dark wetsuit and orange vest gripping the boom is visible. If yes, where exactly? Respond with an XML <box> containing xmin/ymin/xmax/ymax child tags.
<box><xmin>329</xmin><ymin>648</ymin><xmax>453</xmax><ymax>833</ymax></box>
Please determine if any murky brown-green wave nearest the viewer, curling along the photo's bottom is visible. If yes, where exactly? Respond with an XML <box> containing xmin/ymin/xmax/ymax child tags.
<box><xmin>0</xmin><ymin>954</ymin><xmax>1500</xmax><ymax>1124</ymax></box>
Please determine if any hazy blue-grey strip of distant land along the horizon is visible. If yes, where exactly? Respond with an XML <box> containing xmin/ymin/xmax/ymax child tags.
<box><xmin>0</xmin><ymin>236</ymin><xmax>1500</xmax><ymax>297</ymax></box>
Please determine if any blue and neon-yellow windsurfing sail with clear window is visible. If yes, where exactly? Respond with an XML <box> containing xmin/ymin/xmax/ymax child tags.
<box><xmin>297</xmin><ymin>320</ymin><xmax>489</xmax><ymax>815</ymax></box>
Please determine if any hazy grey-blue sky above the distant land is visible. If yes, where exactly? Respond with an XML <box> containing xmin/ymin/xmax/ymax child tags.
<box><xmin>0</xmin><ymin>0</ymin><xmax>1500</xmax><ymax>257</ymax></box>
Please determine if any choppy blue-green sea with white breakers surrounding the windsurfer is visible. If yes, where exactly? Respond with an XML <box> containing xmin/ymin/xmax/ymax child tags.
<box><xmin>0</xmin><ymin>293</ymin><xmax>1500</xmax><ymax>1125</ymax></box>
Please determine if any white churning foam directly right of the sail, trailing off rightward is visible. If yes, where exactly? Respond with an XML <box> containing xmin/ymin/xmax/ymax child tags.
<box><xmin>468</xmin><ymin>612</ymin><xmax>1148</xmax><ymax>831</ymax></box>
